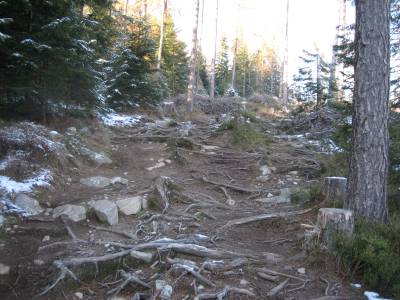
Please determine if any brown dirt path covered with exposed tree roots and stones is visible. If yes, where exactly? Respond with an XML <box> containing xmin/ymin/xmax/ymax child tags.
<box><xmin>0</xmin><ymin>101</ymin><xmax>364</xmax><ymax>300</ymax></box>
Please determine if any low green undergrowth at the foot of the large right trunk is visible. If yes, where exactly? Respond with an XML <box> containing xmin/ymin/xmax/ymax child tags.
<box><xmin>336</xmin><ymin>215</ymin><xmax>400</xmax><ymax>299</ymax></box>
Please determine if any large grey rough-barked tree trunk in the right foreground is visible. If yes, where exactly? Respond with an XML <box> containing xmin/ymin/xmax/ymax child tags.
<box><xmin>346</xmin><ymin>0</ymin><xmax>390</xmax><ymax>222</ymax></box>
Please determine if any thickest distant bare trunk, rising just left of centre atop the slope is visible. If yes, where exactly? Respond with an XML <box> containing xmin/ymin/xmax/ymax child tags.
<box><xmin>187</xmin><ymin>0</ymin><xmax>200</xmax><ymax>112</ymax></box>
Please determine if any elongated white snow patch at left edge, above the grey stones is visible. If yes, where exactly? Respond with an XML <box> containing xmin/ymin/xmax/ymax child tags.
<box><xmin>0</xmin><ymin>169</ymin><xmax>53</xmax><ymax>193</ymax></box>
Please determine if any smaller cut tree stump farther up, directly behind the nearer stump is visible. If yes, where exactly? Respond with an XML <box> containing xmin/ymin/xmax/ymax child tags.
<box><xmin>322</xmin><ymin>177</ymin><xmax>347</xmax><ymax>207</ymax></box>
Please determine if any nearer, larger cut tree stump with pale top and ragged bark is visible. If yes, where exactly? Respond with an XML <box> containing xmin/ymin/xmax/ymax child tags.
<box><xmin>317</xmin><ymin>208</ymin><xmax>354</xmax><ymax>250</ymax></box>
